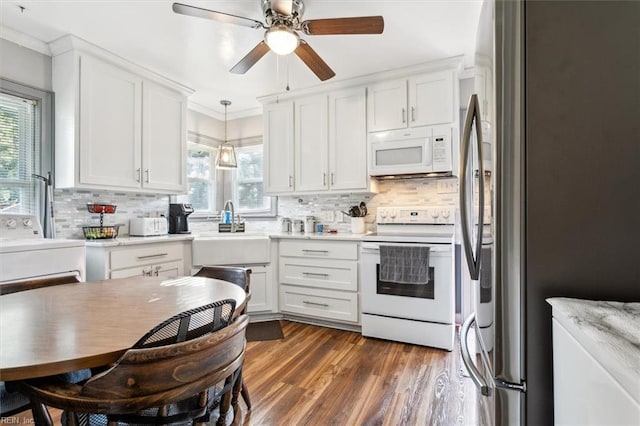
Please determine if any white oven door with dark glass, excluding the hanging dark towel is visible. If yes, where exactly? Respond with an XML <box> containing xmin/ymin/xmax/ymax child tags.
<box><xmin>361</xmin><ymin>242</ymin><xmax>455</xmax><ymax>324</ymax></box>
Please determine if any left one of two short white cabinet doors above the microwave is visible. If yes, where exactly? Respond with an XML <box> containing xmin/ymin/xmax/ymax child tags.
<box><xmin>367</xmin><ymin>79</ymin><xmax>407</xmax><ymax>132</ymax></box>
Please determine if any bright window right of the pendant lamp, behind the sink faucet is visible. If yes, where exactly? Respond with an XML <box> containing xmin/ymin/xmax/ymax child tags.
<box><xmin>232</xmin><ymin>144</ymin><xmax>276</xmax><ymax>216</ymax></box>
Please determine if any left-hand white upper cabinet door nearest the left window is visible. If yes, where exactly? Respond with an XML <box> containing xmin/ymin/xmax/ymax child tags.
<box><xmin>79</xmin><ymin>55</ymin><xmax>142</xmax><ymax>188</ymax></box>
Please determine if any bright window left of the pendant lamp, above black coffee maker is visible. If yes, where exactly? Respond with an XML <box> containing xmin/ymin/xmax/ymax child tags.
<box><xmin>180</xmin><ymin>143</ymin><xmax>217</xmax><ymax>216</ymax></box>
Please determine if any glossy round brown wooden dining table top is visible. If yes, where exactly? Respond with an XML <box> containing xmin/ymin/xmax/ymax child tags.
<box><xmin>0</xmin><ymin>277</ymin><xmax>246</xmax><ymax>381</ymax></box>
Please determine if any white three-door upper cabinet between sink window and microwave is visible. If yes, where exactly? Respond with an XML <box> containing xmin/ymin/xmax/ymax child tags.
<box><xmin>263</xmin><ymin>87</ymin><xmax>372</xmax><ymax>198</ymax></box>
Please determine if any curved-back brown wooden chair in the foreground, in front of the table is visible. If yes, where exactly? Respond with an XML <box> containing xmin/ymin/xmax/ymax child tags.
<box><xmin>16</xmin><ymin>299</ymin><xmax>249</xmax><ymax>426</ymax></box>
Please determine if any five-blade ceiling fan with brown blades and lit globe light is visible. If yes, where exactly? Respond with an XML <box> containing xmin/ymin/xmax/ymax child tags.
<box><xmin>173</xmin><ymin>0</ymin><xmax>384</xmax><ymax>81</ymax></box>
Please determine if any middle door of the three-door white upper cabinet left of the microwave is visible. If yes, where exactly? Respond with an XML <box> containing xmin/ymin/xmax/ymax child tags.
<box><xmin>294</xmin><ymin>95</ymin><xmax>329</xmax><ymax>191</ymax></box>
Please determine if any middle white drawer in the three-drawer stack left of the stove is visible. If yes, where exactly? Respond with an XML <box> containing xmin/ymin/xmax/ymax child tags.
<box><xmin>279</xmin><ymin>257</ymin><xmax>358</xmax><ymax>291</ymax></box>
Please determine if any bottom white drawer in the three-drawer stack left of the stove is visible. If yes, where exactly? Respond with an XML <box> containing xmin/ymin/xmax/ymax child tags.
<box><xmin>280</xmin><ymin>285</ymin><xmax>359</xmax><ymax>323</ymax></box>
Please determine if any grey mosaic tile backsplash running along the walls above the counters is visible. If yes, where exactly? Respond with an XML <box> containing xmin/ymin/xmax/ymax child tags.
<box><xmin>54</xmin><ymin>177</ymin><xmax>458</xmax><ymax>239</ymax></box>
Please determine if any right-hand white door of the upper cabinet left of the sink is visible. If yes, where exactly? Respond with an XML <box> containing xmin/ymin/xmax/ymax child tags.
<box><xmin>142</xmin><ymin>81</ymin><xmax>187</xmax><ymax>192</ymax></box>
